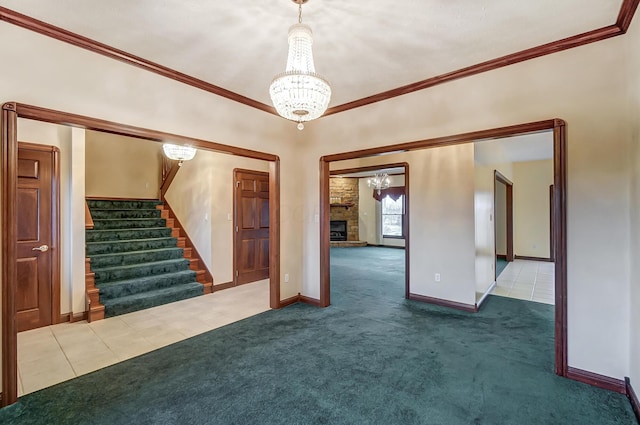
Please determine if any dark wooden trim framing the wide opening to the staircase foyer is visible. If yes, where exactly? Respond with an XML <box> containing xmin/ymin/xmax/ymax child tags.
<box><xmin>0</xmin><ymin>102</ymin><xmax>281</xmax><ymax>406</ymax></box>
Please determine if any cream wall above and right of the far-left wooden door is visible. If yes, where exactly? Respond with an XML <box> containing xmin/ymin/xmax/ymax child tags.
<box><xmin>18</xmin><ymin>119</ymin><xmax>85</xmax><ymax>314</ymax></box>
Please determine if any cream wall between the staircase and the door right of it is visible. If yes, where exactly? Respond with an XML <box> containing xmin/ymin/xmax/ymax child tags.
<box><xmin>165</xmin><ymin>150</ymin><xmax>269</xmax><ymax>285</ymax></box>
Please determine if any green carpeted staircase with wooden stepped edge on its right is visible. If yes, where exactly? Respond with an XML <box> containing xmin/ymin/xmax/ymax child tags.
<box><xmin>86</xmin><ymin>199</ymin><xmax>204</xmax><ymax>317</ymax></box>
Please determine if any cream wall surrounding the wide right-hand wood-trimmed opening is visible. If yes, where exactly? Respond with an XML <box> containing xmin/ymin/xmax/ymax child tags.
<box><xmin>301</xmin><ymin>24</ymin><xmax>640</xmax><ymax>378</ymax></box>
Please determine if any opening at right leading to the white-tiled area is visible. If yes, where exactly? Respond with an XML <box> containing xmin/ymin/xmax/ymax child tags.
<box><xmin>474</xmin><ymin>130</ymin><xmax>554</xmax><ymax>305</ymax></box>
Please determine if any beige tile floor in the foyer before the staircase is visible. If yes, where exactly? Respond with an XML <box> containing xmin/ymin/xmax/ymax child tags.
<box><xmin>18</xmin><ymin>280</ymin><xmax>269</xmax><ymax>396</ymax></box>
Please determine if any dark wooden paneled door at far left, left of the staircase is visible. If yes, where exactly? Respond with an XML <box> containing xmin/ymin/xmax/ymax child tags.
<box><xmin>16</xmin><ymin>144</ymin><xmax>54</xmax><ymax>332</ymax></box>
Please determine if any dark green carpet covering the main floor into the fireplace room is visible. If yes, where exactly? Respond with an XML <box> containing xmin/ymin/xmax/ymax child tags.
<box><xmin>0</xmin><ymin>248</ymin><xmax>636</xmax><ymax>425</ymax></box>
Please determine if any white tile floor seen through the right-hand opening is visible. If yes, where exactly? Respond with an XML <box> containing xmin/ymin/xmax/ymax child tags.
<box><xmin>491</xmin><ymin>260</ymin><xmax>555</xmax><ymax>304</ymax></box>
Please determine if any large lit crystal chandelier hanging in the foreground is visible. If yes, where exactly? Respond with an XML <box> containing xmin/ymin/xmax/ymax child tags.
<box><xmin>269</xmin><ymin>0</ymin><xmax>331</xmax><ymax>130</ymax></box>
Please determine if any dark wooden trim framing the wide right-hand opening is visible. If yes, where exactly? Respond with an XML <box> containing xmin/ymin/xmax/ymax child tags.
<box><xmin>320</xmin><ymin>118</ymin><xmax>568</xmax><ymax>376</ymax></box>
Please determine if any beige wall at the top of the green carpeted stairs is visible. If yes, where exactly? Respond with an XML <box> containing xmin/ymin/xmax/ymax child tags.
<box><xmin>85</xmin><ymin>130</ymin><xmax>162</xmax><ymax>199</ymax></box>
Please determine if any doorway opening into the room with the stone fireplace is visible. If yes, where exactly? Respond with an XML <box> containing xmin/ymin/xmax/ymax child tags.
<box><xmin>327</xmin><ymin>161</ymin><xmax>409</xmax><ymax>302</ymax></box>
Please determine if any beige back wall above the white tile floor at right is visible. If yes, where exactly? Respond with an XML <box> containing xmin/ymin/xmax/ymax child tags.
<box><xmin>513</xmin><ymin>159</ymin><xmax>553</xmax><ymax>258</ymax></box>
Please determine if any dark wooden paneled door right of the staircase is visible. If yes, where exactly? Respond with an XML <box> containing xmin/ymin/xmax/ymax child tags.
<box><xmin>234</xmin><ymin>170</ymin><xmax>269</xmax><ymax>285</ymax></box>
